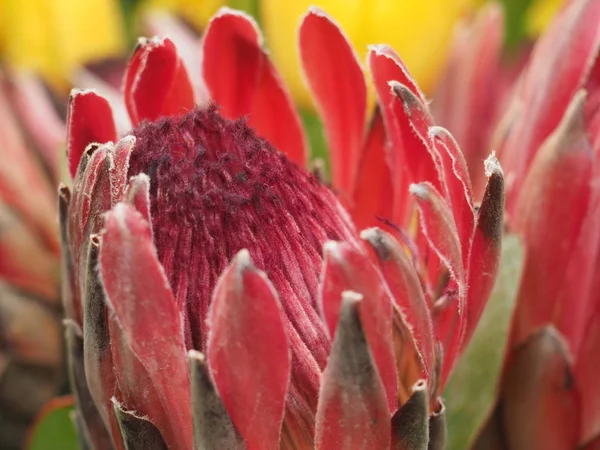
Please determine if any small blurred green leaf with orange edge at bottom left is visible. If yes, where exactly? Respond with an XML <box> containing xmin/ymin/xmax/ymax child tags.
<box><xmin>27</xmin><ymin>397</ymin><xmax>80</xmax><ymax>450</ymax></box>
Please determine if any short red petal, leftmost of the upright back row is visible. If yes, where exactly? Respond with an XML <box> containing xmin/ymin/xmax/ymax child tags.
<box><xmin>67</xmin><ymin>89</ymin><xmax>117</xmax><ymax>178</ymax></box>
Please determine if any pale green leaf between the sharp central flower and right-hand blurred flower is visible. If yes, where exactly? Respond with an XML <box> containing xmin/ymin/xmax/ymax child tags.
<box><xmin>444</xmin><ymin>235</ymin><xmax>523</xmax><ymax>450</ymax></box>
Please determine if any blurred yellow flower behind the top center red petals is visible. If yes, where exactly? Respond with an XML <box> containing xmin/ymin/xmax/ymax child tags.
<box><xmin>260</xmin><ymin>0</ymin><xmax>474</xmax><ymax>107</ymax></box>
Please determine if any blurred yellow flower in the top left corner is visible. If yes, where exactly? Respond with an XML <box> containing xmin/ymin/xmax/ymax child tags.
<box><xmin>0</xmin><ymin>0</ymin><xmax>126</xmax><ymax>86</ymax></box>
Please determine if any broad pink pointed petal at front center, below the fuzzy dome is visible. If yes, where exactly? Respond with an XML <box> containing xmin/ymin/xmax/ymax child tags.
<box><xmin>207</xmin><ymin>250</ymin><xmax>291</xmax><ymax>450</ymax></box>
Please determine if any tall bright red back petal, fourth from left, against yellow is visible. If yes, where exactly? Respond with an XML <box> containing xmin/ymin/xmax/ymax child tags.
<box><xmin>299</xmin><ymin>7</ymin><xmax>367</xmax><ymax>197</ymax></box>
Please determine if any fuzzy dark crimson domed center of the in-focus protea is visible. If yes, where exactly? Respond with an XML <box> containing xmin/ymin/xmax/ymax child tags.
<box><xmin>129</xmin><ymin>107</ymin><xmax>355</xmax><ymax>356</ymax></box>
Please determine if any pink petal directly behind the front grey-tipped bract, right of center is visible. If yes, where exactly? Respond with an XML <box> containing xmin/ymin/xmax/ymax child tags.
<box><xmin>319</xmin><ymin>241</ymin><xmax>398</xmax><ymax>411</ymax></box>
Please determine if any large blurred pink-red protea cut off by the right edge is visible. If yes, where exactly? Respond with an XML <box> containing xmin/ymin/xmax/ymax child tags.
<box><xmin>476</xmin><ymin>0</ymin><xmax>600</xmax><ymax>450</ymax></box>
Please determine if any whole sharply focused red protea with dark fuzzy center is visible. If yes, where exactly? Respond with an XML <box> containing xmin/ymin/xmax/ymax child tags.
<box><xmin>60</xmin><ymin>9</ymin><xmax>503</xmax><ymax>449</ymax></box>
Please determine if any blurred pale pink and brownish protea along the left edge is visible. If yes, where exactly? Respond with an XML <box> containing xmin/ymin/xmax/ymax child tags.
<box><xmin>0</xmin><ymin>72</ymin><xmax>66</xmax><ymax>449</ymax></box>
